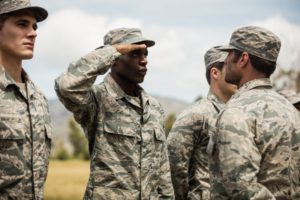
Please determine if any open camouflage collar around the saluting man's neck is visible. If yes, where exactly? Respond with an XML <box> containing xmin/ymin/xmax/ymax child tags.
<box><xmin>104</xmin><ymin>74</ymin><xmax>149</xmax><ymax>108</ymax></box>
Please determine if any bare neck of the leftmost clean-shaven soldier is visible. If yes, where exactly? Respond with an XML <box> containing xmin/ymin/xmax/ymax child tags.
<box><xmin>0</xmin><ymin>53</ymin><xmax>23</xmax><ymax>83</ymax></box>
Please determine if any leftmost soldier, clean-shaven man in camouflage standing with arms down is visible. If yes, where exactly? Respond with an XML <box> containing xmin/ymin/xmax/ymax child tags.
<box><xmin>0</xmin><ymin>0</ymin><xmax>51</xmax><ymax>199</ymax></box>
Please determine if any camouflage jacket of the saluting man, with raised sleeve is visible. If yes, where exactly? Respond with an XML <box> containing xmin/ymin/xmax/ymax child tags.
<box><xmin>56</xmin><ymin>46</ymin><xmax>174</xmax><ymax>200</ymax></box>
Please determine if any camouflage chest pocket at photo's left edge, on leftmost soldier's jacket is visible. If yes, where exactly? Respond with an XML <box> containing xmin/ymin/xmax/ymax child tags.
<box><xmin>0</xmin><ymin>115</ymin><xmax>25</xmax><ymax>188</ymax></box>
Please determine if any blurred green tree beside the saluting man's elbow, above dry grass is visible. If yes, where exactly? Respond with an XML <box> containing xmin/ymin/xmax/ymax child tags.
<box><xmin>69</xmin><ymin>118</ymin><xmax>89</xmax><ymax>160</ymax></box>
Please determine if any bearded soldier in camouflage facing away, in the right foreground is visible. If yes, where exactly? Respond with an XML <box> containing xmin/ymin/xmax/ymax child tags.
<box><xmin>208</xmin><ymin>26</ymin><xmax>300</xmax><ymax>200</ymax></box>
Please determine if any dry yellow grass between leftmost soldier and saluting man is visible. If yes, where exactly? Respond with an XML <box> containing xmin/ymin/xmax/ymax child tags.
<box><xmin>45</xmin><ymin>160</ymin><xmax>89</xmax><ymax>200</ymax></box>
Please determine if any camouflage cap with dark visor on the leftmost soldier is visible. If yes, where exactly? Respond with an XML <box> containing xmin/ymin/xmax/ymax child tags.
<box><xmin>0</xmin><ymin>0</ymin><xmax>48</xmax><ymax>22</ymax></box>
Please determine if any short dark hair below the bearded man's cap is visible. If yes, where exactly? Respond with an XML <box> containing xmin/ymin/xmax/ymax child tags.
<box><xmin>233</xmin><ymin>49</ymin><xmax>276</xmax><ymax>78</ymax></box>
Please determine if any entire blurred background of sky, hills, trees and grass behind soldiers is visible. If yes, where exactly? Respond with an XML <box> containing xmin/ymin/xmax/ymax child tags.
<box><xmin>24</xmin><ymin>0</ymin><xmax>300</xmax><ymax>200</ymax></box>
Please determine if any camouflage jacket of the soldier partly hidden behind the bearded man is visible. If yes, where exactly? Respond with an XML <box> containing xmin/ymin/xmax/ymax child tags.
<box><xmin>168</xmin><ymin>92</ymin><xmax>224</xmax><ymax>200</ymax></box>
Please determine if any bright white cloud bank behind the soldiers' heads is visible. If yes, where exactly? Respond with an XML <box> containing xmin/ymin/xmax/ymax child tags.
<box><xmin>28</xmin><ymin>9</ymin><xmax>300</xmax><ymax>102</ymax></box>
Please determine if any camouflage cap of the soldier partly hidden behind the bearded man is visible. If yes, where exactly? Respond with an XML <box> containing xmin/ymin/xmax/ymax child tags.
<box><xmin>204</xmin><ymin>46</ymin><xmax>228</xmax><ymax>69</ymax></box>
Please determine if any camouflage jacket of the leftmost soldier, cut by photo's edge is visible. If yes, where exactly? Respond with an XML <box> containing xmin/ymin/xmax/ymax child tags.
<box><xmin>0</xmin><ymin>66</ymin><xmax>51</xmax><ymax>199</ymax></box>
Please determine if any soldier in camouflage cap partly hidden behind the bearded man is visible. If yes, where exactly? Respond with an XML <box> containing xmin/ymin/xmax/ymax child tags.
<box><xmin>168</xmin><ymin>46</ymin><xmax>236</xmax><ymax>200</ymax></box>
